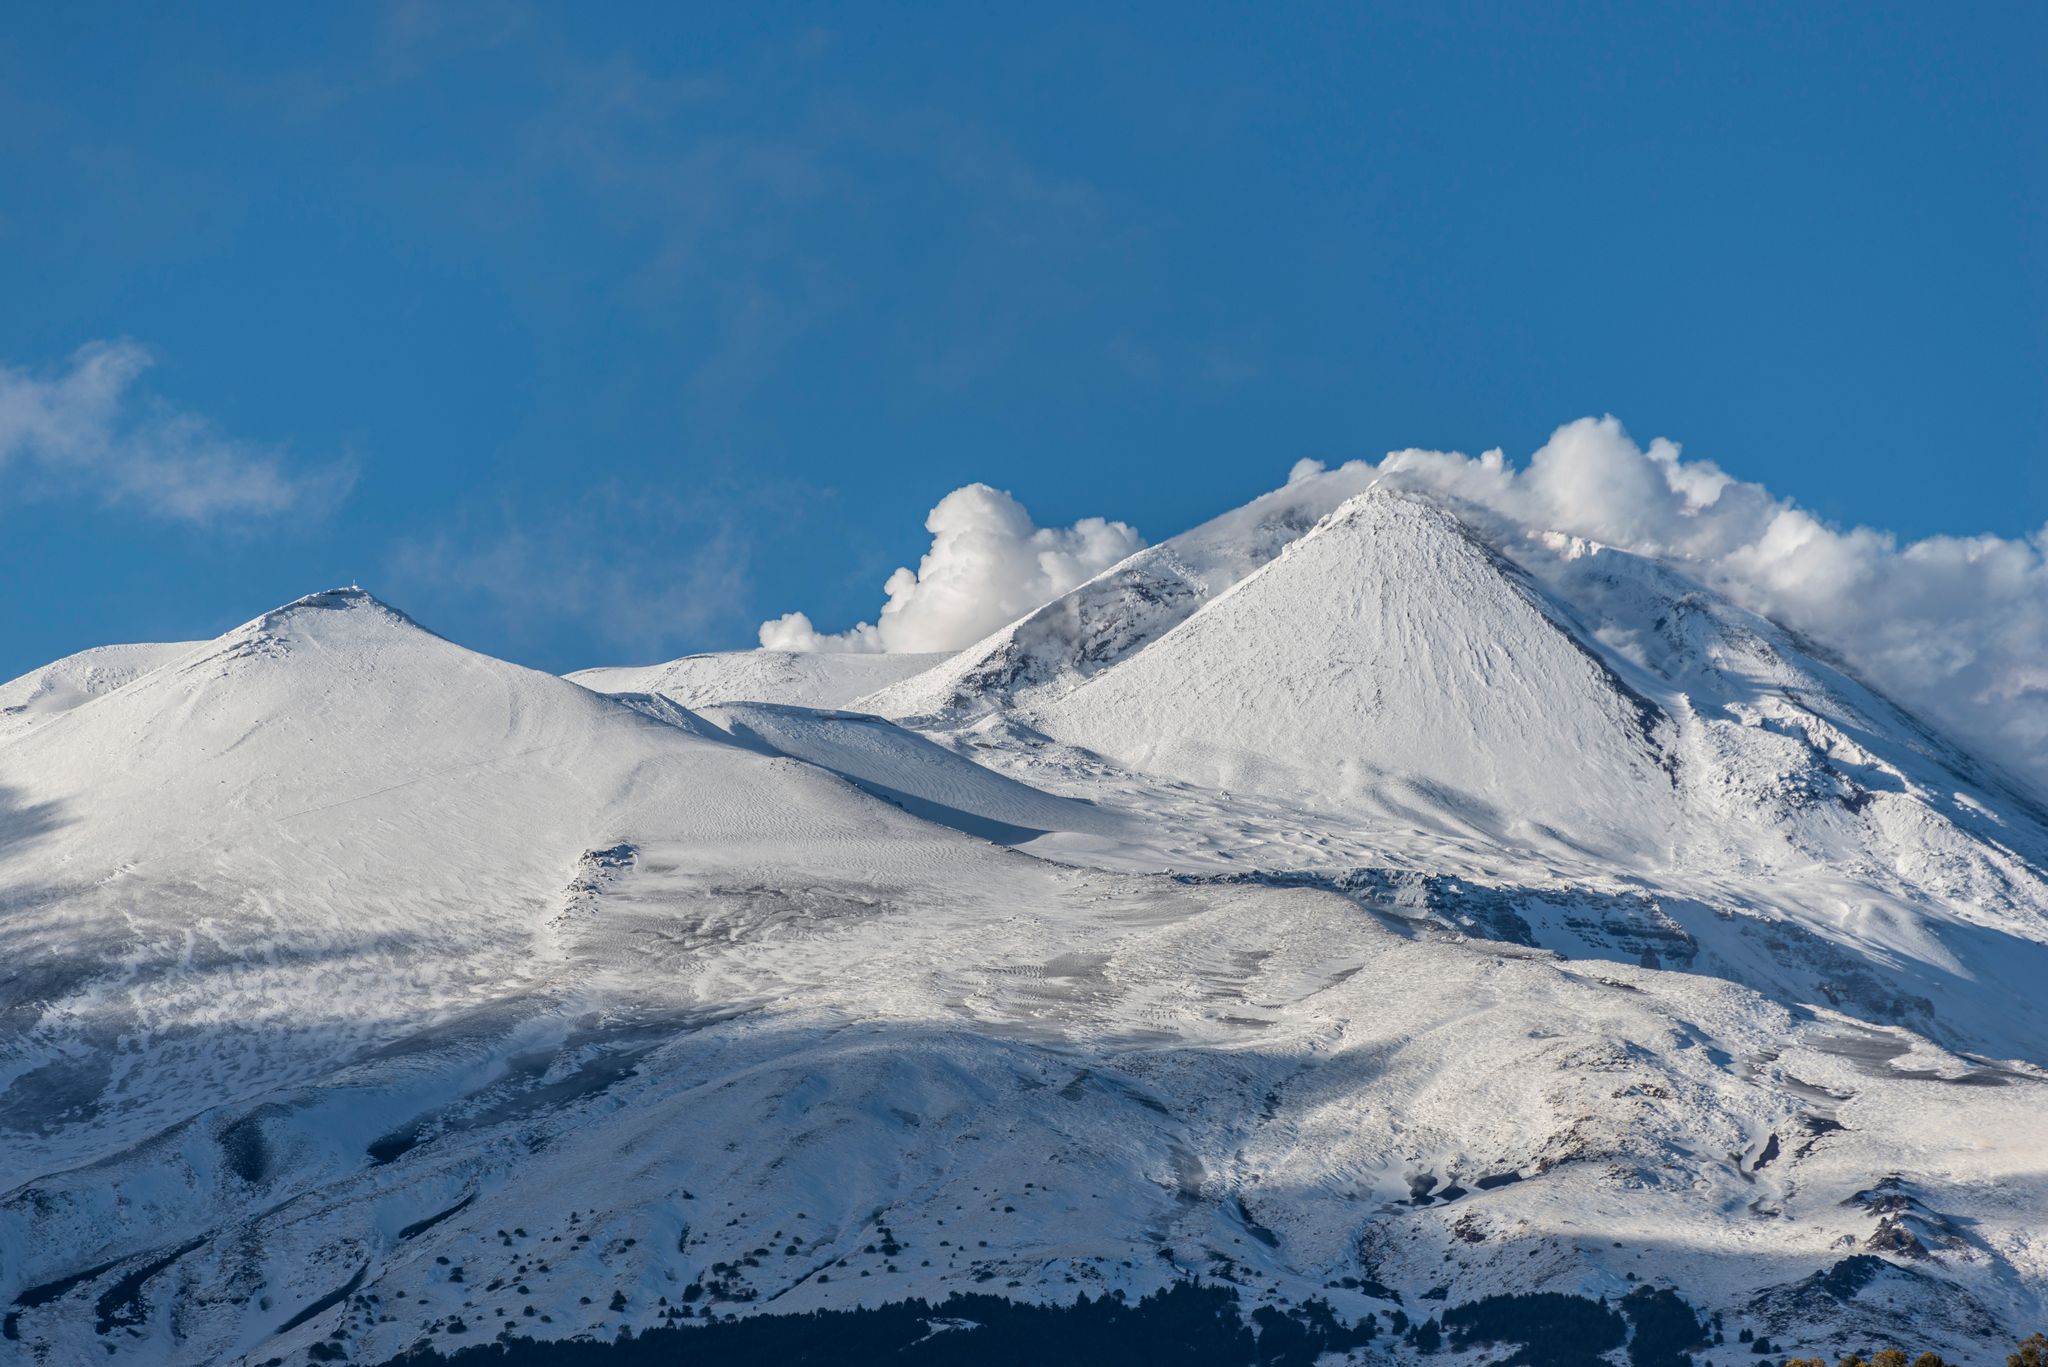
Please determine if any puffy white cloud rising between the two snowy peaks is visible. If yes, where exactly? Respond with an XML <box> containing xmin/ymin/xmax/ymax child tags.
<box><xmin>760</xmin><ymin>484</ymin><xmax>1145</xmax><ymax>652</ymax></box>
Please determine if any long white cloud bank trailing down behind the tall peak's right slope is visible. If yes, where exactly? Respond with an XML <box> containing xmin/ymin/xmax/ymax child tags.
<box><xmin>1359</xmin><ymin>418</ymin><xmax>2048</xmax><ymax>787</ymax></box>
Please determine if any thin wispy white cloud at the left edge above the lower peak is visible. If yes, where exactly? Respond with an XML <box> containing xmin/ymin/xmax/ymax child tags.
<box><xmin>0</xmin><ymin>342</ymin><xmax>354</xmax><ymax>523</ymax></box>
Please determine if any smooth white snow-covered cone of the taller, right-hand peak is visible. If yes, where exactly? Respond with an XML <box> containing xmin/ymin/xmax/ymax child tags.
<box><xmin>1030</xmin><ymin>488</ymin><xmax>1675</xmax><ymax>865</ymax></box>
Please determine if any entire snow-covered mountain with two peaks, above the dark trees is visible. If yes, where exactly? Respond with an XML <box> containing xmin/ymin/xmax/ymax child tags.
<box><xmin>0</xmin><ymin>483</ymin><xmax>2048</xmax><ymax>1363</ymax></box>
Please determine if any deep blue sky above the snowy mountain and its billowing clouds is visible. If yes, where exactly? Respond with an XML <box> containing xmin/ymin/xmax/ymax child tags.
<box><xmin>0</xmin><ymin>4</ymin><xmax>2048</xmax><ymax>676</ymax></box>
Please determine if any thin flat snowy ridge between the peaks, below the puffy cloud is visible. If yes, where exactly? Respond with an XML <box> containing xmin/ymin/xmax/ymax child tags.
<box><xmin>569</xmin><ymin>650</ymin><xmax>946</xmax><ymax>707</ymax></box>
